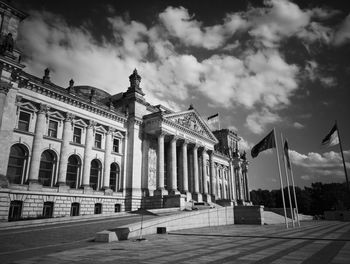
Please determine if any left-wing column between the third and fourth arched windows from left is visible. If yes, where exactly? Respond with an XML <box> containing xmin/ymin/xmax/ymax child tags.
<box><xmin>82</xmin><ymin>120</ymin><xmax>96</xmax><ymax>189</ymax></box>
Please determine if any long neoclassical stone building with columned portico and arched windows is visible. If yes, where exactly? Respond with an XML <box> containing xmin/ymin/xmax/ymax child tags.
<box><xmin>0</xmin><ymin>2</ymin><xmax>249</xmax><ymax>220</ymax></box>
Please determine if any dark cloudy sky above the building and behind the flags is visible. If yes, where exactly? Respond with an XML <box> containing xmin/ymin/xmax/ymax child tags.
<box><xmin>12</xmin><ymin>0</ymin><xmax>350</xmax><ymax>189</ymax></box>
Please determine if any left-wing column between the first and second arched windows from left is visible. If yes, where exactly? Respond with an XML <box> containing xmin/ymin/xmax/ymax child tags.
<box><xmin>29</xmin><ymin>104</ymin><xmax>49</xmax><ymax>183</ymax></box>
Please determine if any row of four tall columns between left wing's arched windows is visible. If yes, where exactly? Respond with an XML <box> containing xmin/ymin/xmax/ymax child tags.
<box><xmin>29</xmin><ymin>104</ymin><xmax>115</xmax><ymax>189</ymax></box>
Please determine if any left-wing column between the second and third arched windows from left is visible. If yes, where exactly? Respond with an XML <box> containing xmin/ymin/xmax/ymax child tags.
<box><xmin>58</xmin><ymin>113</ymin><xmax>74</xmax><ymax>186</ymax></box>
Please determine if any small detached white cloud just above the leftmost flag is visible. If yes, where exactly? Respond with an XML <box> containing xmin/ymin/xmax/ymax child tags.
<box><xmin>245</xmin><ymin>108</ymin><xmax>281</xmax><ymax>134</ymax></box>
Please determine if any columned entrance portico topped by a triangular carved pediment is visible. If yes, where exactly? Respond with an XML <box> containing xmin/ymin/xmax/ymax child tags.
<box><xmin>144</xmin><ymin>108</ymin><xmax>218</xmax><ymax>202</ymax></box>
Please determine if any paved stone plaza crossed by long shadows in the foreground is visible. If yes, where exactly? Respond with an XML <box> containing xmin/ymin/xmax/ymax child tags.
<box><xmin>3</xmin><ymin>221</ymin><xmax>350</xmax><ymax>264</ymax></box>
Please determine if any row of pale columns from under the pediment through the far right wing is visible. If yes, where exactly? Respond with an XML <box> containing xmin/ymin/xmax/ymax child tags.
<box><xmin>155</xmin><ymin>133</ymin><xmax>249</xmax><ymax>201</ymax></box>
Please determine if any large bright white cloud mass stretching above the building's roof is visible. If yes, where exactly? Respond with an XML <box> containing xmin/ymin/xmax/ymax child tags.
<box><xmin>15</xmin><ymin>0</ymin><xmax>340</xmax><ymax>122</ymax></box>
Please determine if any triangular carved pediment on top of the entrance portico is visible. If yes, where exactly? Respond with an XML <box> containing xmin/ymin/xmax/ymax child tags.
<box><xmin>164</xmin><ymin>109</ymin><xmax>218</xmax><ymax>143</ymax></box>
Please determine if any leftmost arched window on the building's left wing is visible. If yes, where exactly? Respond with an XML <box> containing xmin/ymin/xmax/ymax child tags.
<box><xmin>6</xmin><ymin>144</ymin><xmax>28</xmax><ymax>184</ymax></box>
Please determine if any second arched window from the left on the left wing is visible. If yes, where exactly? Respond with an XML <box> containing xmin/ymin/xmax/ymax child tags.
<box><xmin>39</xmin><ymin>150</ymin><xmax>56</xmax><ymax>186</ymax></box>
